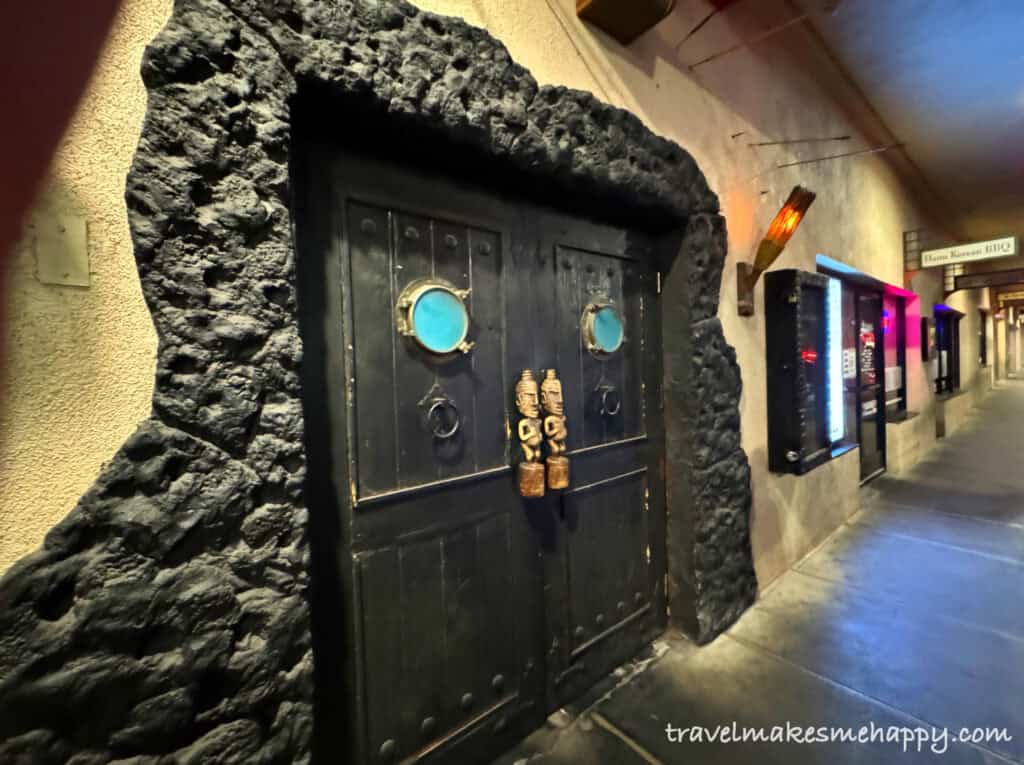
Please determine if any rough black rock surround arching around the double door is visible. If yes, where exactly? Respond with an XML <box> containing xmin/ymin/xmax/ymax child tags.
<box><xmin>0</xmin><ymin>0</ymin><xmax>753</xmax><ymax>764</ymax></box>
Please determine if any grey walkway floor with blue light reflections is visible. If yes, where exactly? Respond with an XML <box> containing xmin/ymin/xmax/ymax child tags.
<box><xmin>498</xmin><ymin>381</ymin><xmax>1024</xmax><ymax>765</ymax></box>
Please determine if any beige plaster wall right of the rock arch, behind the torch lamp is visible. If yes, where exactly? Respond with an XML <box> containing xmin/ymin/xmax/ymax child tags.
<box><xmin>409</xmin><ymin>0</ymin><xmax>991</xmax><ymax>587</ymax></box>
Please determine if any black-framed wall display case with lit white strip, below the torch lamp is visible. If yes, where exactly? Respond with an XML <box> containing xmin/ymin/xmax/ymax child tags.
<box><xmin>765</xmin><ymin>269</ymin><xmax>843</xmax><ymax>474</ymax></box>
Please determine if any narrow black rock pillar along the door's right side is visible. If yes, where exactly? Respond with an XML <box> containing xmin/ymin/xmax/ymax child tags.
<box><xmin>662</xmin><ymin>213</ymin><xmax>757</xmax><ymax>643</ymax></box>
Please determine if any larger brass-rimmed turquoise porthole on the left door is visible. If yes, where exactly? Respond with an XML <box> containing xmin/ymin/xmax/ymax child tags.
<box><xmin>397</xmin><ymin>279</ymin><xmax>473</xmax><ymax>355</ymax></box>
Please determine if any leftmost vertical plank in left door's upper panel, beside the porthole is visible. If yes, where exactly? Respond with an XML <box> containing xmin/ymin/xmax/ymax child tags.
<box><xmin>347</xmin><ymin>203</ymin><xmax>397</xmax><ymax>496</ymax></box>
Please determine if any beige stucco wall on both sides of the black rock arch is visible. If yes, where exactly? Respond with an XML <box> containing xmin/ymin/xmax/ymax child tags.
<box><xmin>0</xmin><ymin>0</ymin><xmax>991</xmax><ymax>586</ymax></box>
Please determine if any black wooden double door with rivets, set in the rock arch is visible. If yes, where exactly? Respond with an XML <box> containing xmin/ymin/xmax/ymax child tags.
<box><xmin>300</xmin><ymin>146</ymin><xmax>666</xmax><ymax>763</ymax></box>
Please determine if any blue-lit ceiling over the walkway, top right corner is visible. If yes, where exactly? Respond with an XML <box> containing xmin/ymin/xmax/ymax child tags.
<box><xmin>805</xmin><ymin>0</ymin><xmax>1024</xmax><ymax>240</ymax></box>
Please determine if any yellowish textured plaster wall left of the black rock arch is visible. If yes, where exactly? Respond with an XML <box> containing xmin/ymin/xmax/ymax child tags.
<box><xmin>0</xmin><ymin>0</ymin><xmax>171</xmax><ymax>572</ymax></box>
